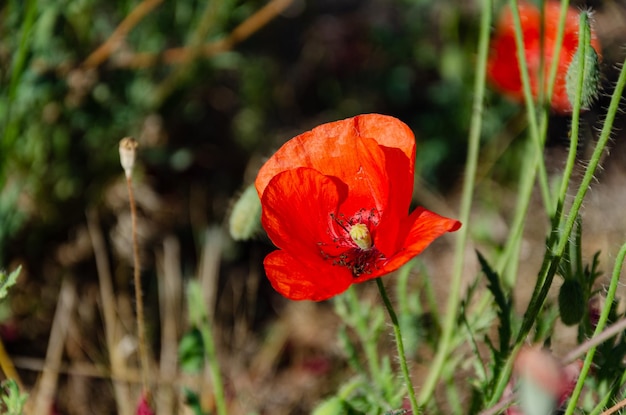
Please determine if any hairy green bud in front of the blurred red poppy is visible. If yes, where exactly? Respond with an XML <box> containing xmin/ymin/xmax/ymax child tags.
<box><xmin>565</xmin><ymin>12</ymin><xmax>600</xmax><ymax>108</ymax></box>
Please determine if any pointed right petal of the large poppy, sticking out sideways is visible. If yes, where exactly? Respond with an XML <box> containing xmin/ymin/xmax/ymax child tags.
<box><xmin>379</xmin><ymin>207</ymin><xmax>461</xmax><ymax>275</ymax></box>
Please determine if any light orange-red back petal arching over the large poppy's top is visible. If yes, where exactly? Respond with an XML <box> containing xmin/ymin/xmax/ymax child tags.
<box><xmin>255</xmin><ymin>114</ymin><xmax>415</xmax><ymax>199</ymax></box>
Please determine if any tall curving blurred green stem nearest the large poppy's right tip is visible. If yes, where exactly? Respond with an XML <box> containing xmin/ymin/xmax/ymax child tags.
<box><xmin>419</xmin><ymin>0</ymin><xmax>492</xmax><ymax>406</ymax></box>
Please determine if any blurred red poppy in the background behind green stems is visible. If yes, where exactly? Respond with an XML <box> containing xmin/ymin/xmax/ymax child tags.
<box><xmin>487</xmin><ymin>1</ymin><xmax>600</xmax><ymax>114</ymax></box>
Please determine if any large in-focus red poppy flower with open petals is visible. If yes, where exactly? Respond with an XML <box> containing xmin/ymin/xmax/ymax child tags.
<box><xmin>255</xmin><ymin>114</ymin><xmax>461</xmax><ymax>301</ymax></box>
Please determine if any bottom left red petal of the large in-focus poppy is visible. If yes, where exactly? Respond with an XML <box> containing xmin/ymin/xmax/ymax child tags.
<box><xmin>263</xmin><ymin>251</ymin><xmax>353</xmax><ymax>301</ymax></box>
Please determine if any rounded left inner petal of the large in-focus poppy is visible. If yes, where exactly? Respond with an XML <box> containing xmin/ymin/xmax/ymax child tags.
<box><xmin>261</xmin><ymin>168</ymin><xmax>347</xmax><ymax>262</ymax></box>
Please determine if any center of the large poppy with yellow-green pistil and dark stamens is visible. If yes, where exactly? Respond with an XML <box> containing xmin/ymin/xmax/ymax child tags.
<box><xmin>319</xmin><ymin>208</ymin><xmax>386</xmax><ymax>278</ymax></box>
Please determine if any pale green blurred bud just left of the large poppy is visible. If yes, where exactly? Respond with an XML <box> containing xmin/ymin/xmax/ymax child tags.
<box><xmin>228</xmin><ymin>185</ymin><xmax>261</xmax><ymax>241</ymax></box>
